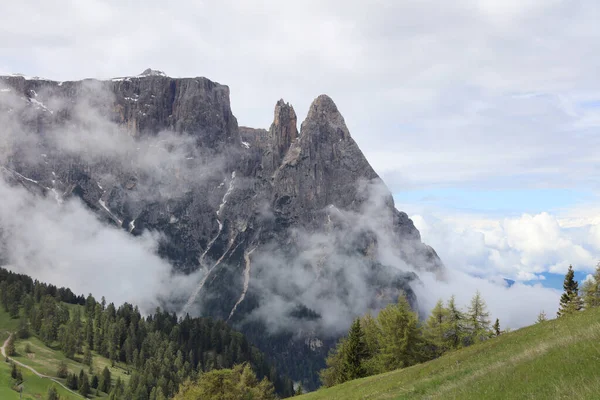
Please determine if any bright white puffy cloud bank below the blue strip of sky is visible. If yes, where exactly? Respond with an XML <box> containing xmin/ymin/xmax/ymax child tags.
<box><xmin>411</xmin><ymin>212</ymin><xmax>600</xmax><ymax>281</ymax></box>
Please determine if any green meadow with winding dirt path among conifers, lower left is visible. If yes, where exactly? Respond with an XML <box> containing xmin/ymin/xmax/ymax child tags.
<box><xmin>0</xmin><ymin>305</ymin><xmax>130</xmax><ymax>399</ymax></box>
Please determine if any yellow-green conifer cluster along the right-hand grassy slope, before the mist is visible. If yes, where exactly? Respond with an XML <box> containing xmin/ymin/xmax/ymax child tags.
<box><xmin>320</xmin><ymin>292</ymin><xmax>502</xmax><ymax>387</ymax></box>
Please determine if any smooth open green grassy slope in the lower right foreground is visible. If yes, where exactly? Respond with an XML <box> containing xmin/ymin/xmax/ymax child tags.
<box><xmin>300</xmin><ymin>309</ymin><xmax>600</xmax><ymax>400</ymax></box>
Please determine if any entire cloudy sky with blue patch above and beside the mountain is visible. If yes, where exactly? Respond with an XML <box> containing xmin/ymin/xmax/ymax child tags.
<box><xmin>0</xmin><ymin>0</ymin><xmax>600</xmax><ymax>324</ymax></box>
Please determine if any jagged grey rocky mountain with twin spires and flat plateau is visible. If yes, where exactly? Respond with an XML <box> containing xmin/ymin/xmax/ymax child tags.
<box><xmin>0</xmin><ymin>70</ymin><xmax>444</xmax><ymax>387</ymax></box>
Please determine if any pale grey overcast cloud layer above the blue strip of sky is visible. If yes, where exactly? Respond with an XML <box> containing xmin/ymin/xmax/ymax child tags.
<box><xmin>0</xmin><ymin>0</ymin><xmax>600</xmax><ymax>189</ymax></box>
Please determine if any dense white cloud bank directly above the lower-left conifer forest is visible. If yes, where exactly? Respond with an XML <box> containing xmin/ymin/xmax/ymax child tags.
<box><xmin>0</xmin><ymin>178</ymin><xmax>199</xmax><ymax>312</ymax></box>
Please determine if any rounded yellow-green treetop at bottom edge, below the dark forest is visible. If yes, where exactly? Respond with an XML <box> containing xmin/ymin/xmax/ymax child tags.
<box><xmin>173</xmin><ymin>364</ymin><xmax>276</xmax><ymax>400</ymax></box>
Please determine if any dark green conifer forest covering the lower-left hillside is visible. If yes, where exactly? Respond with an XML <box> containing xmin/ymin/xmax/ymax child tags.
<box><xmin>0</xmin><ymin>268</ymin><xmax>294</xmax><ymax>400</ymax></box>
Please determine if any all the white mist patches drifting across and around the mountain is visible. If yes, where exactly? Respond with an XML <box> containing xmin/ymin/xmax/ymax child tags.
<box><xmin>0</xmin><ymin>76</ymin><xmax>559</xmax><ymax>336</ymax></box>
